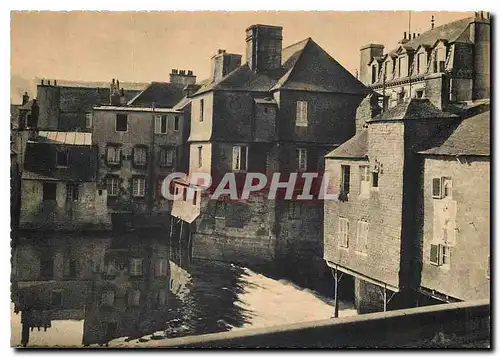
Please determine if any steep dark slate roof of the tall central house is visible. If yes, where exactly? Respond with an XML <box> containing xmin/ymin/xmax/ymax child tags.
<box><xmin>191</xmin><ymin>38</ymin><xmax>367</xmax><ymax>95</ymax></box>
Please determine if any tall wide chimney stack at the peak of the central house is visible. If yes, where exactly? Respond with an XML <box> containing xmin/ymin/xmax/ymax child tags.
<box><xmin>246</xmin><ymin>25</ymin><xmax>283</xmax><ymax>72</ymax></box>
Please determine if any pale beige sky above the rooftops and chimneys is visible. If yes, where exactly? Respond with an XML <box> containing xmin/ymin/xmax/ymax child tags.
<box><xmin>11</xmin><ymin>11</ymin><xmax>471</xmax><ymax>100</ymax></box>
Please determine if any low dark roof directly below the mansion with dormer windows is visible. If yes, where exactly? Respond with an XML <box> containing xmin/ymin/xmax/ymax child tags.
<box><xmin>369</xmin><ymin>98</ymin><xmax>458</xmax><ymax>122</ymax></box>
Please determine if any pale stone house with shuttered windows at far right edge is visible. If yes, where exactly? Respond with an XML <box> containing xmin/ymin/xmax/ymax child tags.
<box><xmin>416</xmin><ymin>110</ymin><xmax>491</xmax><ymax>302</ymax></box>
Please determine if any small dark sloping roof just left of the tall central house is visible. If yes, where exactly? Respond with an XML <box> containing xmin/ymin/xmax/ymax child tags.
<box><xmin>127</xmin><ymin>82</ymin><xmax>185</xmax><ymax>108</ymax></box>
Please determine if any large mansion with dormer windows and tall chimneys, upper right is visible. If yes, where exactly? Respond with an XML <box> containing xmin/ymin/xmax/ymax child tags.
<box><xmin>359</xmin><ymin>11</ymin><xmax>491</xmax><ymax>112</ymax></box>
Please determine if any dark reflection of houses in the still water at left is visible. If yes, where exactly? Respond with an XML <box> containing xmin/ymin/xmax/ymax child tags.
<box><xmin>12</xmin><ymin>232</ymin><xmax>254</xmax><ymax>345</ymax></box>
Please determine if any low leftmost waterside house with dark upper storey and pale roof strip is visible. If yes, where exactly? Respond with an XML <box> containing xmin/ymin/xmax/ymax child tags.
<box><xmin>19</xmin><ymin>131</ymin><xmax>110</xmax><ymax>230</ymax></box>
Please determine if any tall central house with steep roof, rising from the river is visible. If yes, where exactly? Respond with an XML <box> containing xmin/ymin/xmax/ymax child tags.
<box><xmin>173</xmin><ymin>25</ymin><xmax>367</xmax><ymax>272</ymax></box>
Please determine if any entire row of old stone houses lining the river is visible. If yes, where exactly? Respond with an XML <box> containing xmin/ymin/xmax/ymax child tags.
<box><xmin>12</xmin><ymin>13</ymin><xmax>490</xmax><ymax>311</ymax></box>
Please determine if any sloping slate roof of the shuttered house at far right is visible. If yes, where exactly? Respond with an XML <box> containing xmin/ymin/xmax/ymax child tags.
<box><xmin>415</xmin><ymin>110</ymin><xmax>491</xmax><ymax>157</ymax></box>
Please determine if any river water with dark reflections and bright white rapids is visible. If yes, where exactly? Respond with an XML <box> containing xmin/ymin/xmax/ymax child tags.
<box><xmin>11</xmin><ymin>232</ymin><xmax>356</xmax><ymax>347</ymax></box>
